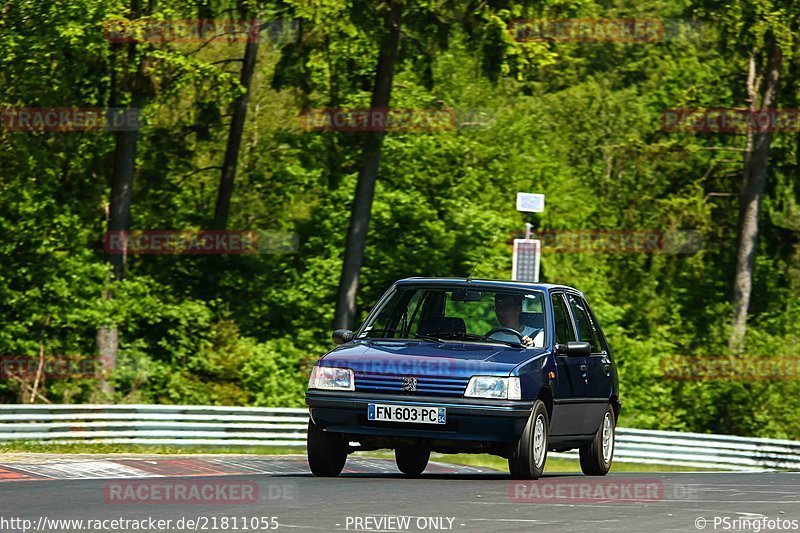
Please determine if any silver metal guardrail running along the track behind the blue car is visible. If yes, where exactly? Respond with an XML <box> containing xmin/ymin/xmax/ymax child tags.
<box><xmin>0</xmin><ymin>404</ymin><xmax>800</xmax><ymax>470</ymax></box>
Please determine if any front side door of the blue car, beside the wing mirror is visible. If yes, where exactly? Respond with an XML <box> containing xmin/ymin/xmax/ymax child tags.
<box><xmin>550</xmin><ymin>291</ymin><xmax>588</xmax><ymax>436</ymax></box>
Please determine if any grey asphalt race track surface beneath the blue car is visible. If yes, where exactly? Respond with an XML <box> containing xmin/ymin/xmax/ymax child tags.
<box><xmin>0</xmin><ymin>456</ymin><xmax>800</xmax><ymax>533</ymax></box>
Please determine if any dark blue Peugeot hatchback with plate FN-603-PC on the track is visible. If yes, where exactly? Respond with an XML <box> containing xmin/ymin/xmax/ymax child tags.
<box><xmin>306</xmin><ymin>278</ymin><xmax>620</xmax><ymax>479</ymax></box>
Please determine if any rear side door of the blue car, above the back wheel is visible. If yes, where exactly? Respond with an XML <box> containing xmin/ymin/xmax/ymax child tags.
<box><xmin>567</xmin><ymin>293</ymin><xmax>614</xmax><ymax>433</ymax></box>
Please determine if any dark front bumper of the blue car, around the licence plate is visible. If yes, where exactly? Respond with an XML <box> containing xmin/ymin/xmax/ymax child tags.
<box><xmin>306</xmin><ymin>389</ymin><xmax>533</xmax><ymax>443</ymax></box>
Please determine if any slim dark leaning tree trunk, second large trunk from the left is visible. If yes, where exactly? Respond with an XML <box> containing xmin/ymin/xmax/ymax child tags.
<box><xmin>214</xmin><ymin>24</ymin><xmax>258</xmax><ymax>230</ymax></box>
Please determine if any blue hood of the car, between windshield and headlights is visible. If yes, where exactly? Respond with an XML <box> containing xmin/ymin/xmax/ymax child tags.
<box><xmin>319</xmin><ymin>341</ymin><xmax>543</xmax><ymax>378</ymax></box>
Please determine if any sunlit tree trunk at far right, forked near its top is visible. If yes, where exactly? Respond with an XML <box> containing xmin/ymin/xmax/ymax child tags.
<box><xmin>728</xmin><ymin>41</ymin><xmax>782</xmax><ymax>353</ymax></box>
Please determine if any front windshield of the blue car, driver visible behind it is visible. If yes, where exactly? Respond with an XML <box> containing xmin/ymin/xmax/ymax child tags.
<box><xmin>358</xmin><ymin>287</ymin><xmax>545</xmax><ymax>348</ymax></box>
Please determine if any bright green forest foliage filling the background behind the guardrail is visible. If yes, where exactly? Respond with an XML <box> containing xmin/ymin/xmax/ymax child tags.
<box><xmin>0</xmin><ymin>0</ymin><xmax>800</xmax><ymax>438</ymax></box>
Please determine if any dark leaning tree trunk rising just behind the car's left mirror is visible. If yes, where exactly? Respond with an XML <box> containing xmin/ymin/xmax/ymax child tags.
<box><xmin>334</xmin><ymin>0</ymin><xmax>401</xmax><ymax>328</ymax></box>
